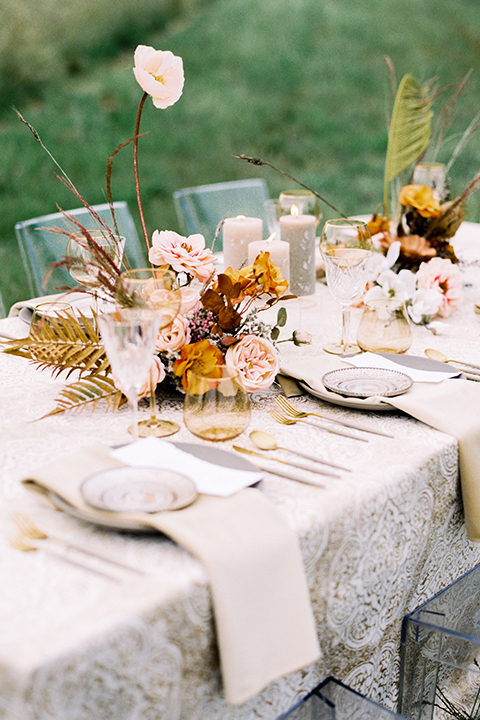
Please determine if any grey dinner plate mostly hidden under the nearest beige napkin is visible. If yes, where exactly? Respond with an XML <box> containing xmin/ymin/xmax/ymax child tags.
<box><xmin>49</xmin><ymin>442</ymin><xmax>258</xmax><ymax>534</ymax></box>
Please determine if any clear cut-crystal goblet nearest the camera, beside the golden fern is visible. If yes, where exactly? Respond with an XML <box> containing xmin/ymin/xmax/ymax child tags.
<box><xmin>97</xmin><ymin>307</ymin><xmax>160</xmax><ymax>440</ymax></box>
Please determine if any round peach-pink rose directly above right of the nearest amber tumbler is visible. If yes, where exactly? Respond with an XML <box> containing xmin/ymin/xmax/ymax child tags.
<box><xmin>225</xmin><ymin>335</ymin><xmax>279</xmax><ymax>392</ymax></box>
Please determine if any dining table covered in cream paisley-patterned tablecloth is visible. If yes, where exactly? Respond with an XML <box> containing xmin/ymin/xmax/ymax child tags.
<box><xmin>0</xmin><ymin>222</ymin><xmax>480</xmax><ymax>720</ymax></box>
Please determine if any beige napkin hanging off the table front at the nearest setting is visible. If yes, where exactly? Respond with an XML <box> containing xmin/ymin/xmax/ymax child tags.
<box><xmin>23</xmin><ymin>444</ymin><xmax>320</xmax><ymax>705</ymax></box>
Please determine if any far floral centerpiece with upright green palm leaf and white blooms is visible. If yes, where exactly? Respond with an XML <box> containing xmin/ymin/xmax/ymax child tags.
<box><xmin>237</xmin><ymin>64</ymin><xmax>480</xmax><ymax>331</ymax></box>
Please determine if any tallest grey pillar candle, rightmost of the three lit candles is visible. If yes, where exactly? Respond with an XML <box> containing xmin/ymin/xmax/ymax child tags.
<box><xmin>280</xmin><ymin>215</ymin><xmax>317</xmax><ymax>297</ymax></box>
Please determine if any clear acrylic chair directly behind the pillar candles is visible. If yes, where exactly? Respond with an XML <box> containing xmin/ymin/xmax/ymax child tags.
<box><xmin>173</xmin><ymin>178</ymin><xmax>269</xmax><ymax>252</ymax></box>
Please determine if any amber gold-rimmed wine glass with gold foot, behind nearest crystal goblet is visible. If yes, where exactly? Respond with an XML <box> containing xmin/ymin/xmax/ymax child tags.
<box><xmin>116</xmin><ymin>268</ymin><xmax>181</xmax><ymax>437</ymax></box>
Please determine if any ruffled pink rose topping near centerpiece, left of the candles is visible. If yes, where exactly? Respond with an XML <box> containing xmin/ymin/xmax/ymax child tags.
<box><xmin>148</xmin><ymin>230</ymin><xmax>215</xmax><ymax>282</ymax></box>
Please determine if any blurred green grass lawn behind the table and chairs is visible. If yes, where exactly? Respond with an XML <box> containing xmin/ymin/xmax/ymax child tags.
<box><xmin>0</xmin><ymin>0</ymin><xmax>480</xmax><ymax>306</ymax></box>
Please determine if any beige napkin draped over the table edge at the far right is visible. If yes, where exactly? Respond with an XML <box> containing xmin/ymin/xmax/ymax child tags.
<box><xmin>281</xmin><ymin>353</ymin><xmax>480</xmax><ymax>542</ymax></box>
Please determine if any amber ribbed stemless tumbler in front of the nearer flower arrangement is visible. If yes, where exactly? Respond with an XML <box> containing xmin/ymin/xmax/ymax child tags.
<box><xmin>183</xmin><ymin>365</ymin><xmax>251</xmax><ymax>440</ymax></box>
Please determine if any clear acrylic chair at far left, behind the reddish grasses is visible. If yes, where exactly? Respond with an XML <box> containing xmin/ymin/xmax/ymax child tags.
<box><xmin>15</xmin><ymin>201</ymin><xmax>146</xmax><ymax>297</ymax></box>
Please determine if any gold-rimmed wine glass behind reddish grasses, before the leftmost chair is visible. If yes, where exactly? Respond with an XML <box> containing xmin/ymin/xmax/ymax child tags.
<box><xmin>65</xmin><ymin>230</ymin><xmax>125</xmax><ymax>313</ymax></box>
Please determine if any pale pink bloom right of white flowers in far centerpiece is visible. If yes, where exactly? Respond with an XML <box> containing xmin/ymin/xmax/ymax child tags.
<box><xmin>417</xmin><ymin>257</ymin><xmax>463</xmax><ymax>317</ymax></box>
